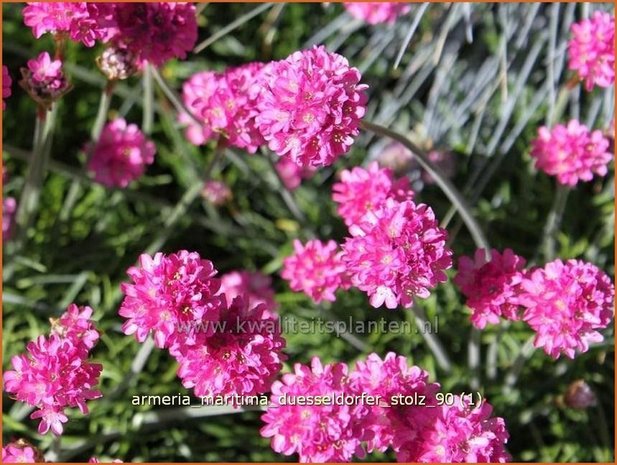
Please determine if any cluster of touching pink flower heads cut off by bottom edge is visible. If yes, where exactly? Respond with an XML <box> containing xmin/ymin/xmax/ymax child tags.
<box><xmin>261</xmin><ymin>353</ymin><xmax>510</xmax><ymax>462</ymax></box>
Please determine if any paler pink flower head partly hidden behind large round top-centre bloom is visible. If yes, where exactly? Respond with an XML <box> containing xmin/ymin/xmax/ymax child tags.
<box><xmin>179</xmin><ymin>63</ymin><xmax>264</xmax><ymax>153</ymax></box>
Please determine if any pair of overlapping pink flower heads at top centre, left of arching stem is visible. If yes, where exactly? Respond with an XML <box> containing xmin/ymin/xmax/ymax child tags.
<box><xmin>180</xmin><ymin>46</ymin><xmax>367</xmax><ymax>167</ymax></box>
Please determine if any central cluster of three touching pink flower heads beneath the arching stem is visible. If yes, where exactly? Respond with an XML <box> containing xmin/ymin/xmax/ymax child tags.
<box><xmin>282</xmin><ymin>163</ymin><xmax>452</xmax><ymax>309</ymax></box>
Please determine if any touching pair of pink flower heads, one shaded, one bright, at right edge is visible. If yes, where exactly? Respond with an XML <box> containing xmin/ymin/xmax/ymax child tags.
<box><xmin>454</xmin><ymin>249</ymin><xmax>615</xmax><ymax>359</ymax></box>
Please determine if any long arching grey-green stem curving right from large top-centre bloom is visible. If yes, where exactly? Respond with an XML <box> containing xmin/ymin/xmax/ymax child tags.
<box><xmin>360</xmin><ymin>121</ymin><xmax>491</xmax><ymax>252</ymax></box>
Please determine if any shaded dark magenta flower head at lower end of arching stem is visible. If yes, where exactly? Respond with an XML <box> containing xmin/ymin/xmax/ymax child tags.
<box><xmin>454</xmin><ymin>249</ymin><xmax>525</xmax><ymax>329</ymax></box>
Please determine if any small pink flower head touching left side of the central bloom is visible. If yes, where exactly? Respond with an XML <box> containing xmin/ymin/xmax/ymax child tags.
<box><xmin>281</xmin><ymin>239</ymin><xmax>349</xmax><ymax>303</ymax></box>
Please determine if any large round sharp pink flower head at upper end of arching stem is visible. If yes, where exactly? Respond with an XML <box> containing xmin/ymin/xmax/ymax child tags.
<box><xmin>256</xmin><ymin>46</ymin><xmax>367</xmax><ymax>167</ymax></box>
